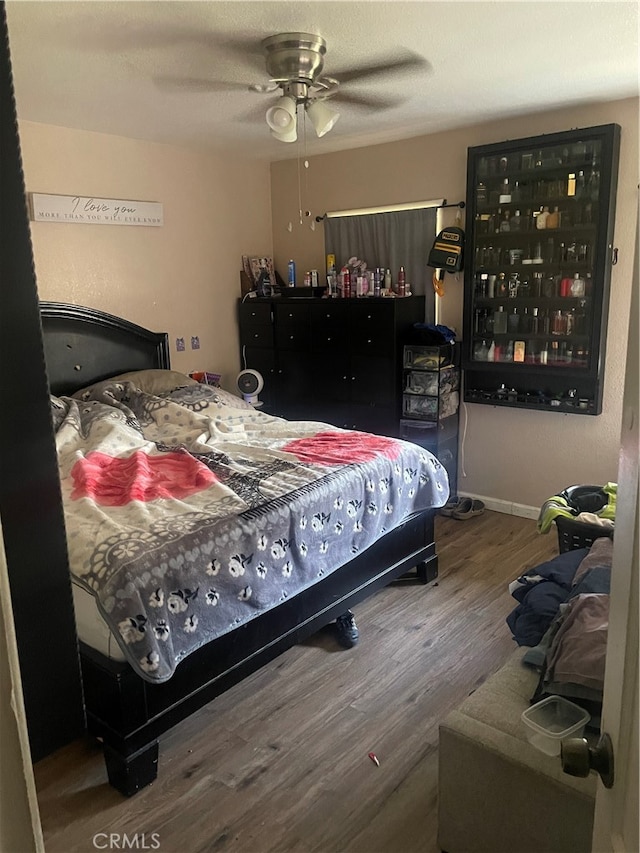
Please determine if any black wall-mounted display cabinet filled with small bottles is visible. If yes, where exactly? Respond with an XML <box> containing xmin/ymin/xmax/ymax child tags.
<box><xmin>462</xmin><ymin>124</ymin><xmax>620</xmax><ymax>415</ymax></box>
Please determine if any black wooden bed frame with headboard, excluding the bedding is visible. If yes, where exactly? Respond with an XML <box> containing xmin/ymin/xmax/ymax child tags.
<box><xmin>40</xmin><ymin>302</ymin><xmax>438</xmax><ymax>796</ymax></box>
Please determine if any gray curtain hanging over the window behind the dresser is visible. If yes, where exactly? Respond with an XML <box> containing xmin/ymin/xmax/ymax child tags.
<box><xmin>324</xmin><ymin>207</ymin><xmax>438</xmax><ymax>323</ymax></box>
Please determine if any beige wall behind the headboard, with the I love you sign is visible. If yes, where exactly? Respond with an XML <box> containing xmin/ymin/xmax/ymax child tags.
<box><xmin>19</xmin><ymin>121</ymin><xmax>271</xmax><ymax>388</ymax></box>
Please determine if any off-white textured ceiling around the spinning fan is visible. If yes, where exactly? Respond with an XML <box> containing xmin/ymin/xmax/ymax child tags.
<box><xmin>6</xmin><ymin>0</ymin><xmax>638</xmax><ymax>160</ymax></box>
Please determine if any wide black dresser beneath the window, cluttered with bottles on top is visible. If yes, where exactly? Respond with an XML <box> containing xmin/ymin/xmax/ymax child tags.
<box><xmin>238</xmin><ymin>296</ymin><xmax>425</xmax><ymax>436</ymax></box>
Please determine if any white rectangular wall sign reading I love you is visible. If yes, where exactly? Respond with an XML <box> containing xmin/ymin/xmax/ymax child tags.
<box><xmin>29</xmin><ymin>193</ymin><xmax>164</xmax><ymax>227</ymax></box>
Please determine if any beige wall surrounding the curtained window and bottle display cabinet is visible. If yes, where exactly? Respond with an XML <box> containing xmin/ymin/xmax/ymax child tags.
<box><xmin>271</xmin><ymin>99</ymin><xmax>638</xmax><ymax>507</ymax></box>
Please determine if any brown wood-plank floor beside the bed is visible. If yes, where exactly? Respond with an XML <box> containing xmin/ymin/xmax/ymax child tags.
<box><xmin>36</xmin><ymin>511</ymin><xmax>557</xmax><ymax>853</ymax></box>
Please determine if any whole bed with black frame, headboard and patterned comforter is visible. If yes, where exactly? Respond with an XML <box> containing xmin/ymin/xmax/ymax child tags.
<box><xmin>40</xmin><ymin>302</ymin><xmax>448</xmax><ymax>796</ymax></box>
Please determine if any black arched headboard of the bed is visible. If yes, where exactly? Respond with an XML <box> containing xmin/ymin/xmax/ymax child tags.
<box><xmin>40</xmin><ymin>302</ymin><xmax>171</xmax><ymax>396</ymax></box>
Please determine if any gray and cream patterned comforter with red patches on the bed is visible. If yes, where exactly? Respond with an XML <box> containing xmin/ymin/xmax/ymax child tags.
<box><xmin>51</xmin><ymin>382</ymin><xmax>448</xmax><ymax>682</ymax></box>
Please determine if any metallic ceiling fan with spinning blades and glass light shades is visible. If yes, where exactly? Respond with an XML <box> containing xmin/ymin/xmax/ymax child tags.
<box><xmin>155</xmin><ymin>33</ymin><xmax>429</xmax><ymax>142</ymax></box>
